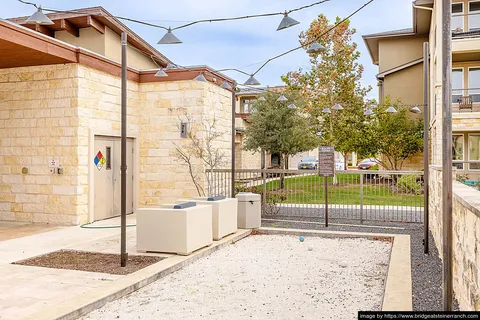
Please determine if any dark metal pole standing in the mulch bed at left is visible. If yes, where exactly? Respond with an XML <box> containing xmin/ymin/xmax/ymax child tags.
<box><xmin>120</xmin><ymin>32</ymin><xmax>128</xmax><ymax>267</ymax></box>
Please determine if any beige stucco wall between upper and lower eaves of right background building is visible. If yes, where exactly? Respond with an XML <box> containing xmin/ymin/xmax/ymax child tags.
<box><xmin>378</xmin><ymin>37</ymin><xmax>428</xmax><ymax>72</ymax></box>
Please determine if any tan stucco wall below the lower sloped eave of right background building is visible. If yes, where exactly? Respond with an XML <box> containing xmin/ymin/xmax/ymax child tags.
<box><xmin>383</xmin><ymin>63</ymin><xmax>423</xmax><ymax>104</ymax></box>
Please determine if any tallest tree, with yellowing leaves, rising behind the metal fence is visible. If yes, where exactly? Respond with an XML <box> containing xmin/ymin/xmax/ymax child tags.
<box><xmin>282</xmin><ymin>14</ymin><xmax>371</xmax><ymax>165</ymax></box>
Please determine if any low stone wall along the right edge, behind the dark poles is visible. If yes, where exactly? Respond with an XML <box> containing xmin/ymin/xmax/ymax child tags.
<box><xmin>429</xmin><ymin>169</ymin><xmax>480</xmax><ymax>311</ymax></box>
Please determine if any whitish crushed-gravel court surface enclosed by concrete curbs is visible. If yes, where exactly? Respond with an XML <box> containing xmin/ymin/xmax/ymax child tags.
<box><xmin>83</xmin><ymin>235</ymin><xmax>391</xmax><ymax>320</ymax></box>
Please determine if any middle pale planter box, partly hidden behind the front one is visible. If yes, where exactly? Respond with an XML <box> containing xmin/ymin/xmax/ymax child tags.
<box><xmin>177</xmin><ymin>198</ymin><xmax>238</xmax><ymax>240</ymax></box>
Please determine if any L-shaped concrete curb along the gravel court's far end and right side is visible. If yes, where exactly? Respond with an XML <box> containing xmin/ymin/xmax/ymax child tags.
<box><xmin>257</xmin><ymin>228</ymin><xmax>413</xmax><ymax>311</ymax></box>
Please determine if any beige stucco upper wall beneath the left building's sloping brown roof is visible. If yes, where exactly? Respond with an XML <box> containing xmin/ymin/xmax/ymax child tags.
<box><xmin>55</xmin><ymin>27</ymin><xmax>157</xmax><ymax>70</ymax></box>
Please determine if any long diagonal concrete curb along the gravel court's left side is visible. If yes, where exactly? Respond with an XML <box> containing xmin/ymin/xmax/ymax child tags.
<box><xmin>24</xmin><ymin>229</ymin><xmax>251</xmax><ymax>320</ymax></box>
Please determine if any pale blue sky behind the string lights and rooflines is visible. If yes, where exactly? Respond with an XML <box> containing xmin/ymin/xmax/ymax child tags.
<box><xmin>1</xmin><ymin>0</ymin><xmax>412</xmax><ymax>98</ymax></box>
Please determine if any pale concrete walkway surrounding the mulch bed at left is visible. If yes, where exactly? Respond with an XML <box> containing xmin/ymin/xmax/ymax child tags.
<box><xmin>0</xmin><ymin>215</ymin><xmax>249</xmax><ymax>320</ymax></box>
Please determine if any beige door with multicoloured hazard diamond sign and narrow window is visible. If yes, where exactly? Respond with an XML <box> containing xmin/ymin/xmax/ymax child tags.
<box><xmin>93</xmin><ymin>137</ymin><xmax>133</xmax><ymax>220</ymax></box>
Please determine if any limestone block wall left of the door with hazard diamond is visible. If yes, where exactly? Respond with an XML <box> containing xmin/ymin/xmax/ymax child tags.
<box><xmin>0</xmin><ymin>64</ymin><xmax>83</xmax><ymax>224</ymax></box>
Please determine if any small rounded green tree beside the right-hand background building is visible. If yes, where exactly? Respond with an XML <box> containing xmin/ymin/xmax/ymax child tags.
<box><xmin>362</xmin><ymin>96</ymin><xmax>423</xmax><ymax>170</ymax></box>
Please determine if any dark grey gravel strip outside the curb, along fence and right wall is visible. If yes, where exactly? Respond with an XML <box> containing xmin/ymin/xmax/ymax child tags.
<box><xmin>262</xmin><ymin>216</ymin><xmax>458</xmax><ymax>311</ymax></box>
